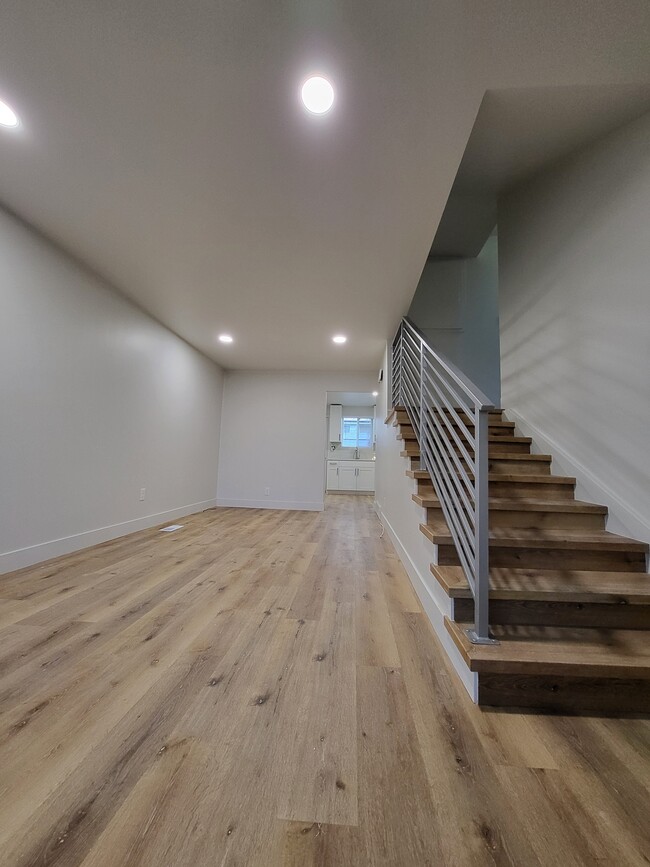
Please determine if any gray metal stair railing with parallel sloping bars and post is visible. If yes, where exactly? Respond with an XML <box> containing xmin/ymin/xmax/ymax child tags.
<box><xmin>391</xmin><ymin>318</ymin><xmax>496</xmax><ymax>644</ymax></box>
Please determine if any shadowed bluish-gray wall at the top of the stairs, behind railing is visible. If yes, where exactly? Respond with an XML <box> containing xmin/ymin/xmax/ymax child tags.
<box><xmin>408</xmin><ymin>235</ymin><xmax>501</xmax><ymax>406</ymax></box>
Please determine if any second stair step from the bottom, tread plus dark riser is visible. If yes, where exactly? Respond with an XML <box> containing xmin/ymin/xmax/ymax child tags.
<box><xmin>430</xmin><ymin>564</ymin><xmax>650</xmax><ymax>630</ymax></box>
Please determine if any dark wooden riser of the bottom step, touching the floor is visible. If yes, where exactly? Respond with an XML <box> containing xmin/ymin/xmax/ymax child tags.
<box><xmin>478</xmin><ymin>673</ymin><xmax>650</xmax><ymax>716</ymax></box>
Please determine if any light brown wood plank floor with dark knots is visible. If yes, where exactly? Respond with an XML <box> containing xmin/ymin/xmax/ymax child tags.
<box><xmin>0</xmin><ymin>495</ymin><xmax>650</xmax><ymax>867</ymax></box>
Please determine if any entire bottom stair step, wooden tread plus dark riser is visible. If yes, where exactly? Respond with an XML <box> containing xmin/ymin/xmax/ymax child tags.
<box><xmin>445</xmin><ymin>618</ymin><xmax>650</xmax><ymax>716</ymax></box>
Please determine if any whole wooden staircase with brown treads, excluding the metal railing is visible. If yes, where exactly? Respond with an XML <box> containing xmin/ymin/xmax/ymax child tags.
<box><xmin>386</xmin><ymin>322</ymin><xmax>650</xmax><ymax>715</ymax></box>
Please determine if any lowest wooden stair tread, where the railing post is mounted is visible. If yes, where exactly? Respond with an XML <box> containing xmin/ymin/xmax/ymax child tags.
<box><xmin>445</xmin><ymin>617</ymin><xmax>650</xmax><ymax>688</ymax></box>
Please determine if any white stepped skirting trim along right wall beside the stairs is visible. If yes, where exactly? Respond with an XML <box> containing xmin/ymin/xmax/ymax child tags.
<box><xmin>506</xmin><ymin>409</ymin><xmax>650</xmax><ymax>542</ymax></box>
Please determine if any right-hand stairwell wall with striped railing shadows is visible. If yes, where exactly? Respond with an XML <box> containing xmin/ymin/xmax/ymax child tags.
<box><xmin>499</xmin><ymin>108</ymin><xmax>650</xmax><ymax>541</ymax></box>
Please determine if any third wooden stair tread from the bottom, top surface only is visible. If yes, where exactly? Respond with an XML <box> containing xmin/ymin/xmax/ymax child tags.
<box><xmin>420</xmin><ymin>521</ymin><xmax>650</xmax><ymax>552</ymax></box>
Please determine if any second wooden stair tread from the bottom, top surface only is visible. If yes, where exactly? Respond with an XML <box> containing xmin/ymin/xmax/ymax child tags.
<box><xmin>429</xmin><ymin>564</ymin><xmax>650</xmax><ymax>605</ymax></box>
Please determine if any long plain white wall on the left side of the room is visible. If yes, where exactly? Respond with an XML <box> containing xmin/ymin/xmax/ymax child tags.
<box><xmin>0</xmin><ymin>212</ymin><xmax>222</xmax><ymax>571</ymax></box>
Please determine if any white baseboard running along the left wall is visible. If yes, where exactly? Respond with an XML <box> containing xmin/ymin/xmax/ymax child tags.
<box><xmin>0</xmin><ymin>500</ymin><xmax>216</xmax><ymax>575</ymax></box>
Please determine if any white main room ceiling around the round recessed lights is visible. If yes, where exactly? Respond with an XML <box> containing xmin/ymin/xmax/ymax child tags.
<box><xmin>0</xmin><ymin>0</ymin><xmax>650</xmax><ymax>370</ymax></box>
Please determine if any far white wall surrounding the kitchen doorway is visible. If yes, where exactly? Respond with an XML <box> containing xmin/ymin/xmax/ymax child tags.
<box><xmin>217</xmin><ymin>371</ymin><xmax>377</xmax><ymax>510</ymax></box>
